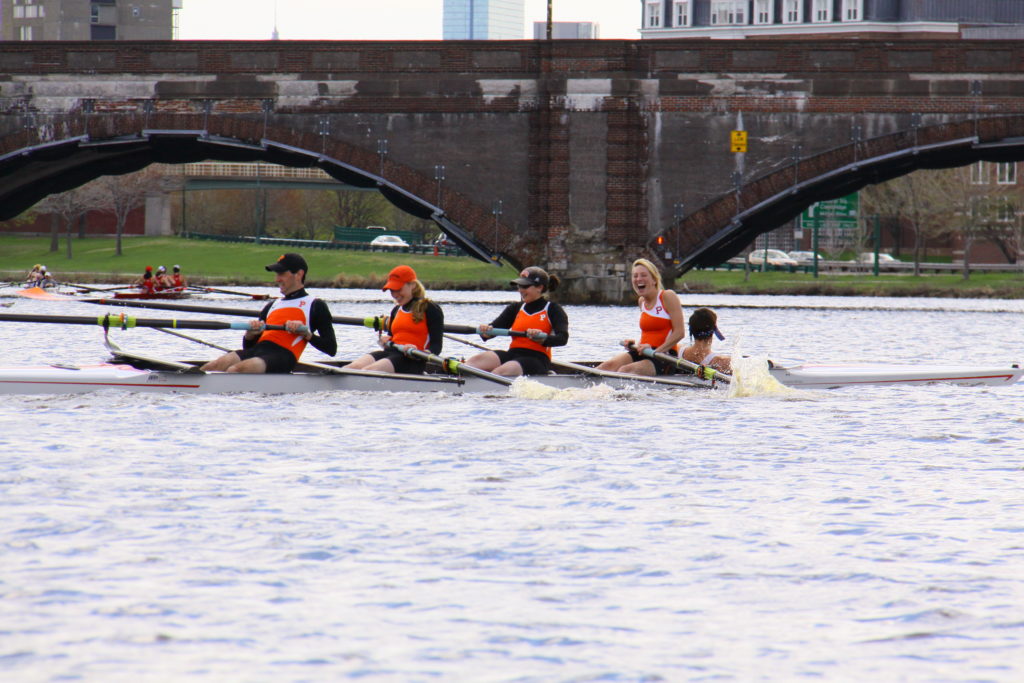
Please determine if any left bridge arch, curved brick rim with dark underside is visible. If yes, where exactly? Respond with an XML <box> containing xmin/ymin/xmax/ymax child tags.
<box><xmin>0</xmin><ymin>114</ymin><xmax>507</xmax><ymax>265</ymax></box>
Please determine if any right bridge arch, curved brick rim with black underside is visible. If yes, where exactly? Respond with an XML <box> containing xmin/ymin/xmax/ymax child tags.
<box><xmin>648</xmin><ymin>116</ymin><xmax>1024</xmax><ymax>275</ymax></box>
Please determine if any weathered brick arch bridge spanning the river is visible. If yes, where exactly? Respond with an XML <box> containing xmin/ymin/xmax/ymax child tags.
<box><xmin>0</xmin><ymin>40</ymin><xmax>1024</xmax><ymax>301</ymax></box>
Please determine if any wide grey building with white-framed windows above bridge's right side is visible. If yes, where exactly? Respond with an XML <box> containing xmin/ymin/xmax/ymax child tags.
<box><xmin>640</xmin><ymin>0</ymin><xmax>1024</xmax><ymax>39</ymax></box>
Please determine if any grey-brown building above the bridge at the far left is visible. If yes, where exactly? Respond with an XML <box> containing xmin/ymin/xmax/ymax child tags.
<box><xmin>0</xmin><ymin>0</ymin><xmax>181</xmax><ymax>40</ymax></box>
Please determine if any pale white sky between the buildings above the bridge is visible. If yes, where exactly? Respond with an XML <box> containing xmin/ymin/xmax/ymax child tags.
<box><xmin>178</xmin><ymin>0</ymin><xmax>640</xmax><ymax>40</ymax></box>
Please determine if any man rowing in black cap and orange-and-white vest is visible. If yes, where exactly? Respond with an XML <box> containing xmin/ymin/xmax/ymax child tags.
<box><xmin>202</xmin><ymin>254</ymin><xmax>338</xmax><ymax>373</ymax></box>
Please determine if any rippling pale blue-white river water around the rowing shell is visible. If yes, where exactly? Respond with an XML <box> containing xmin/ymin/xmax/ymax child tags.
<box><xmin>0</xmin><ymin>290</ymin><xmax>1024</xmax><ymax>682</ymax></box>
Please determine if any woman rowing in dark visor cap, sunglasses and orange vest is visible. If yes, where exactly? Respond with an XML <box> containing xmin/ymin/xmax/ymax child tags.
<box><xmin>466</xmin><ymin>266</ymin><xmax>569</xmax><ymax>377</ymax></box>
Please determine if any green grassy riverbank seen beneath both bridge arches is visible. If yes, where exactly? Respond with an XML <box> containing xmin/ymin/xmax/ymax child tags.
<box><xmin>0</xmin><ymin>237</ymin><xmax>1024</xmax><ymax>299</ymax></box>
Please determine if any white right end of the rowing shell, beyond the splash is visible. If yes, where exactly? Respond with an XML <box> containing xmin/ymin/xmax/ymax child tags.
<box><xmin>770</xmin><ymin>364</ymin><xmax>1024</xmax><ymax>389</ymax></box>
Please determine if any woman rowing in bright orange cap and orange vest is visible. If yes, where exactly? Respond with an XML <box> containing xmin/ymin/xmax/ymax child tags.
<box><xmin>348</xmin><ymin>265</ymin><xmax>444</xmax><ymax>375</ymax></box>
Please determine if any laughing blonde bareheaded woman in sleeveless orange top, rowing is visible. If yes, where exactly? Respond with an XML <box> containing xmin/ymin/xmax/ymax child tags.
<box><xmin>598</xmin><ymin>258</ymin><xmax>686</xmax><ymax>377</ymax></box>
